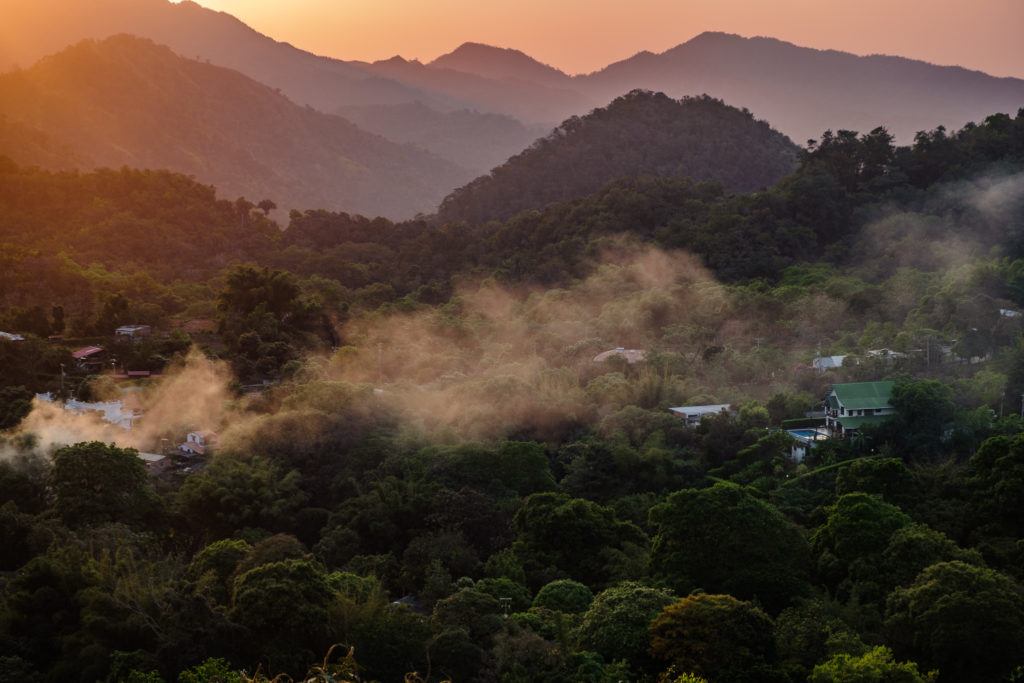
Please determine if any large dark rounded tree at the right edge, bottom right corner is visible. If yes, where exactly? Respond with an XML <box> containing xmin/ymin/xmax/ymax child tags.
<box><xmin>885</xmin><ymin>561</ymin><xmax>1024</xmax><ymax>682</ymax></box>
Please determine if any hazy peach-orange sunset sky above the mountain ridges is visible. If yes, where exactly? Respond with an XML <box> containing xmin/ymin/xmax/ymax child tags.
<box><xmin>184</xmin><ymin>0</ymin><xmax>1024</xmax><ymax>77</ymax></box>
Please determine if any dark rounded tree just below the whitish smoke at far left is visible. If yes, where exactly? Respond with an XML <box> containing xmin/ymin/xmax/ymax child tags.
<box><xmin>50</xmin><ymin>441</ymin><xmax>160</xmax><ymax>528</ymax></box>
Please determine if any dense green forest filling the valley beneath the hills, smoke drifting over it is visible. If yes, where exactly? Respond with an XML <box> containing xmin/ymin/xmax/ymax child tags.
<box><xmin>0</xmin><ymin>104</ymin><xmax>1024</xmax><ymax>683</ymax></box>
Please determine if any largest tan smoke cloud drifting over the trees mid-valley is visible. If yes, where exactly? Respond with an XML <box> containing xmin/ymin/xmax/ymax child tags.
<box><xmin>313</xmin><ymin>241</ymin><xmax>744</xmax><ymax>437</ymax></box>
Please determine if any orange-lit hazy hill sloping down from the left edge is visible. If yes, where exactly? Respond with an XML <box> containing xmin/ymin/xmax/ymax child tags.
<box><xmin>0</xmin><ymin>36</ymin><xmax>467</xmax><ymax>218</ymax></box>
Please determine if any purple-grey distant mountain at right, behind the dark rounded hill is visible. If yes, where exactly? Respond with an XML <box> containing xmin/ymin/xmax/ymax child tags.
<box><xmin>574</xmin><ymin>33</ymin><xmax>1024</xmax><ymax>142</ymax></box>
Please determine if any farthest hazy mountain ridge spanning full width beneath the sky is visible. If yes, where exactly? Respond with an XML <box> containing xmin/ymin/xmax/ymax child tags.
<box><xmin>0</xmin><ymin>0</ymin><xmax>1024</xmax><ymax>148</ymax></box>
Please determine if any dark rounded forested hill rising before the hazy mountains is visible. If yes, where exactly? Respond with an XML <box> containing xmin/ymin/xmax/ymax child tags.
<box><xmin>438</xmin><ymin>90</ymin><xmax>798</xmax><ymax>223</ymax></box>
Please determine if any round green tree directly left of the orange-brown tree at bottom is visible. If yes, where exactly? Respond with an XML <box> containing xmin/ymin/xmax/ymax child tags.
<box><xmin>577</xmin><ymin>581</ymin><xmax>675</xmax><ymax>671</ymax></box>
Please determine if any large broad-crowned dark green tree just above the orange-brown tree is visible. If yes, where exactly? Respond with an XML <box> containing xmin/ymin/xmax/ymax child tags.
<box><xmin>650</xmin><ymin>483</ymin><xmax>810</xmax><ymax>611</ymax></box>
